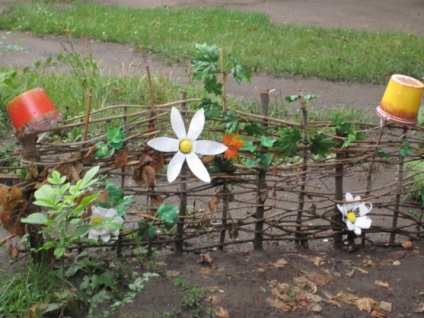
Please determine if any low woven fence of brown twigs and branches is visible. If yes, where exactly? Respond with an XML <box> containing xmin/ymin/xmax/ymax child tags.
<box><xmin>0</xmin><ymin>95</ymin><xmax>423</xmax><ymax>251</ymax></box>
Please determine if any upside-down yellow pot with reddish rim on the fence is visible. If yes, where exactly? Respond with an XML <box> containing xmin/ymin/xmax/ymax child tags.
<box><xmin>376</xmin><ymin>74</ymin><xmax>424</xmax><ymax>126</ymax></box>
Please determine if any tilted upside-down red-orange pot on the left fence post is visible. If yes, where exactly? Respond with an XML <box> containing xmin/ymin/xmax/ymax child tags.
<box><xmin>7</xmin><ymin>87</ymin><xmax>62</xmax><ymax>134</ymax></box>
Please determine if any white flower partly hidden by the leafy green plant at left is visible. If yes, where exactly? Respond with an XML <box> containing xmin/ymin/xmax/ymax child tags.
<box><xmin>88</xmin><ymin>206</ymin><xmax>124</xmax><ymax>242</ymax></box>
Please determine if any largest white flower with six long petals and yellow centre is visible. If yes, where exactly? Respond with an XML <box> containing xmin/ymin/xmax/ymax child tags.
<box><xmin>147</xmin><ymin>107</ymin><xmax>228</xmax><ymax>182</ymax></box>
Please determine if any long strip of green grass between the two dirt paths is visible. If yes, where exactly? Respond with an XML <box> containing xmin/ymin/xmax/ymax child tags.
<box><xmin>0</xmin><ymin>0</ymin><xmax>424</xmax><ymax>83</ymax></box>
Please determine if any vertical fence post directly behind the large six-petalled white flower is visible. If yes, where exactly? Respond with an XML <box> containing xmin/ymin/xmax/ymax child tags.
<box><xmin>175</xmin><ymin>91</ymin><xmax>187</xmax><ymax>254</ymax></box>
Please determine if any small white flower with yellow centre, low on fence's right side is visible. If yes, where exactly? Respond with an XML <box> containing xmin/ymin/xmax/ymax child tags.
<box><xmin>337</xmin><ymin>192</ymin><xmax>372</xmax><ymax>235</ymax></box>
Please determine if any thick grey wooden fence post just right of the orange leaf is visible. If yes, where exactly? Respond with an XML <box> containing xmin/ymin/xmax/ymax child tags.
<box><xmin>253</xmin><ymin>91</ymin><xmax>269</xmax><ymax>250</ymax></box>
